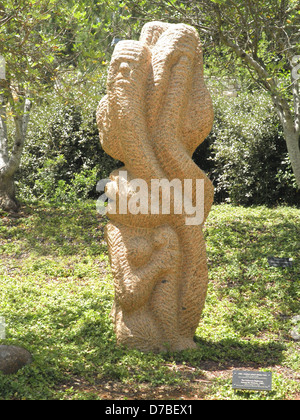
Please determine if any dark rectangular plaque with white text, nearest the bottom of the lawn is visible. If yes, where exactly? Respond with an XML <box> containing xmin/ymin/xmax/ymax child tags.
<box><xmin>232</xmin><ymin>370</ymin><xmax>272</xmax><ymax>391</ymax></box>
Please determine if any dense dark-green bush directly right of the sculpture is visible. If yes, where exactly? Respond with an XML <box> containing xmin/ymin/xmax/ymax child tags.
<box><xmin>194</xmin><ymin>93</ymin><xmax>299</xmax><ymax>205</ymax></box>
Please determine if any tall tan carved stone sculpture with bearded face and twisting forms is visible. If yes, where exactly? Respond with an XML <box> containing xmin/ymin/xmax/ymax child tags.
<box><xmin>97</xmin><ymin>22</ymin><xmax>213</xmax><ymax>351</ymax></box>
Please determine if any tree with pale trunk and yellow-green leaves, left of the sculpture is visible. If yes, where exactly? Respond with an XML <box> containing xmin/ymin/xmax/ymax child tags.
<box><xmin>0</xmin><ymin>0</ymin><xmax>108</xmax><ymax>211</ymax></box>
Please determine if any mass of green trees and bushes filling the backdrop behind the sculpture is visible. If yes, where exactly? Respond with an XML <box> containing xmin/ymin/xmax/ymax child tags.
<box><xmin>0</xmin><ymin>0</ymin><xmax>300</xmax><ymax>206</ymax></box>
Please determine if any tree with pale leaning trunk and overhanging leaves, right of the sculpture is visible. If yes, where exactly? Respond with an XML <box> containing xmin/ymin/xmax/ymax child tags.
<box><xmin>127</xmin><ymin>0</ymin><xmax>300</xmax><ymax>188</ymax></box>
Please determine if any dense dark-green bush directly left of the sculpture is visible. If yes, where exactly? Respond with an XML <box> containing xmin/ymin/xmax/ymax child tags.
<box><xmin>17</xmin><ymin>89</ymin><xmax>120</xmax><ymax>202</ymax></box>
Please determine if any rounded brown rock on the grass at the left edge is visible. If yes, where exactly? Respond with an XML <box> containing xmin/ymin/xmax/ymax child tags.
<box><xmin>0</xmin><ymin>345</ymin><xmax>32</xmax><ymax>375</ymax></box>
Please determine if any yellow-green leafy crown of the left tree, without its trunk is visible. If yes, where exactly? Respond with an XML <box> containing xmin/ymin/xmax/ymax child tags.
<box><xmin>0</xmin><ymin>0</ymin><xmax>109</xmax><ymax>91</ymax></box>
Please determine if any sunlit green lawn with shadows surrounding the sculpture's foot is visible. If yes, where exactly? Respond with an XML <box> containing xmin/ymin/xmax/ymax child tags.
<box><xmin>0</xmin><ymin>202</ymin><xmax>300</xmax><ymax>400</ymax></box>
